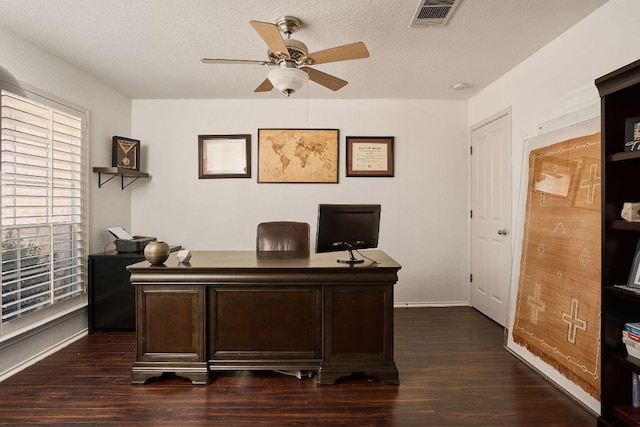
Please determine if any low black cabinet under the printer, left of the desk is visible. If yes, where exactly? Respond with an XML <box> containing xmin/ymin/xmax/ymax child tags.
<box><xmin>88</xmin><ymin>251</ymin><xmax>144</xmax><ymax>334</ymax></box>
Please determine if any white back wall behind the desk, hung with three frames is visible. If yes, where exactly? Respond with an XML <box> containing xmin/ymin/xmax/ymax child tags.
<box><xmin>131</xmin><ymin>97</ymin><xmax>468</xmax><ymax>305</ymax></box>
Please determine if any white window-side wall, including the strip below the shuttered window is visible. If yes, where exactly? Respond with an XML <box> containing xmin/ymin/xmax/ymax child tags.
<box><xmin>0</xmin><ymin>29</ymin><xmax>131</xmax><ymax>380</ymax></box>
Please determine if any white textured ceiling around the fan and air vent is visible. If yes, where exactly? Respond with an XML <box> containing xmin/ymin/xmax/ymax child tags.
<box><xmin>0</xmin><ymin>0</ymin><xmax>606</xmax><ymax>99</ymax></box>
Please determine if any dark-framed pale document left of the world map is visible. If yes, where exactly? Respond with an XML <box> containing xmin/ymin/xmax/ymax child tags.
<box><xmin>198</xmin><ymin>134</ymin><xmax>251</xmax><ymax>179</ymax></box>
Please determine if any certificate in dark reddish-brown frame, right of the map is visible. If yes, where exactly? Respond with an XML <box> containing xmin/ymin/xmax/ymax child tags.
<box><xmin>347</xmin><ymin>136</ymin><xmax>394</xmax><ymax>177</ymax></box>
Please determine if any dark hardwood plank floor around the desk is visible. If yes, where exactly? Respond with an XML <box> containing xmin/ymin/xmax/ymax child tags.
<box><xmin>0</xmin><ymin>307</ymin><xmax>596</xmax><ymax>427</ymax></box>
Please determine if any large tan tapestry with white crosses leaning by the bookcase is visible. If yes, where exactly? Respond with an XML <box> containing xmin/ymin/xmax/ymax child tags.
<box><xmin>512</xmin><ymin>133</ymin><xmax>601</xmax><ymax>398</ymax></box>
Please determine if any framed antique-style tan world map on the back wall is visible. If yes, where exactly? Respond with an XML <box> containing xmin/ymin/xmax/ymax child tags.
<box><xmin>258</xmin><ymin>129</ymin><xmax>338</xmax><ymax>184</ymax></box>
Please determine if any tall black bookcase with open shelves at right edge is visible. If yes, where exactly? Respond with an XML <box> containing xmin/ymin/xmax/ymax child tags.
<box><xmin>596</xmin><ymin>57</ymin><xmax>640</xmax><ymax>426</ymax></box>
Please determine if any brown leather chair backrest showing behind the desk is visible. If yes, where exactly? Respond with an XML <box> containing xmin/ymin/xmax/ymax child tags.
<box><xmin>256</xmin><ymin>221</ymin><xmax>309</xmax><ymax>256</ymax></box>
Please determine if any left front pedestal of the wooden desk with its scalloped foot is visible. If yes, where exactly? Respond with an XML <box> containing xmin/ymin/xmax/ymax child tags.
<box><xmin>131</xmin><ymin>285</ymin><xmax>210</xmax><ymax>384</ymax></box>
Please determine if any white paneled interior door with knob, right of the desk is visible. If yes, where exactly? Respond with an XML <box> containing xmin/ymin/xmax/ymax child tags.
<box><xmin>470</xmin><ymin>113</ymin><xmax>512</xmax><ymax>326</ymax></box>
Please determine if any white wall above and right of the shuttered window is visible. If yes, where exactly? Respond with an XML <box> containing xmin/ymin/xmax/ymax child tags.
<box><xmin>0</xmin><ymin>29</ymin><xmax>131</xmax><ymax>253</ymax></box>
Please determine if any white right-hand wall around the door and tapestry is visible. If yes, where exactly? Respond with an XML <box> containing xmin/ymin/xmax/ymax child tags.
<box><xmin>468</xmin><ymin>0</ymin><xmax>640</xmax><ymax>412</ymax></box>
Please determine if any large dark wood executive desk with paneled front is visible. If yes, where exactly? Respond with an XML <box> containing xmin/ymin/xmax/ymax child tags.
<box><xmin>127</xmin><ymin>250</ymin><xmax>401</xmax><ymax>384</ymax></box>
